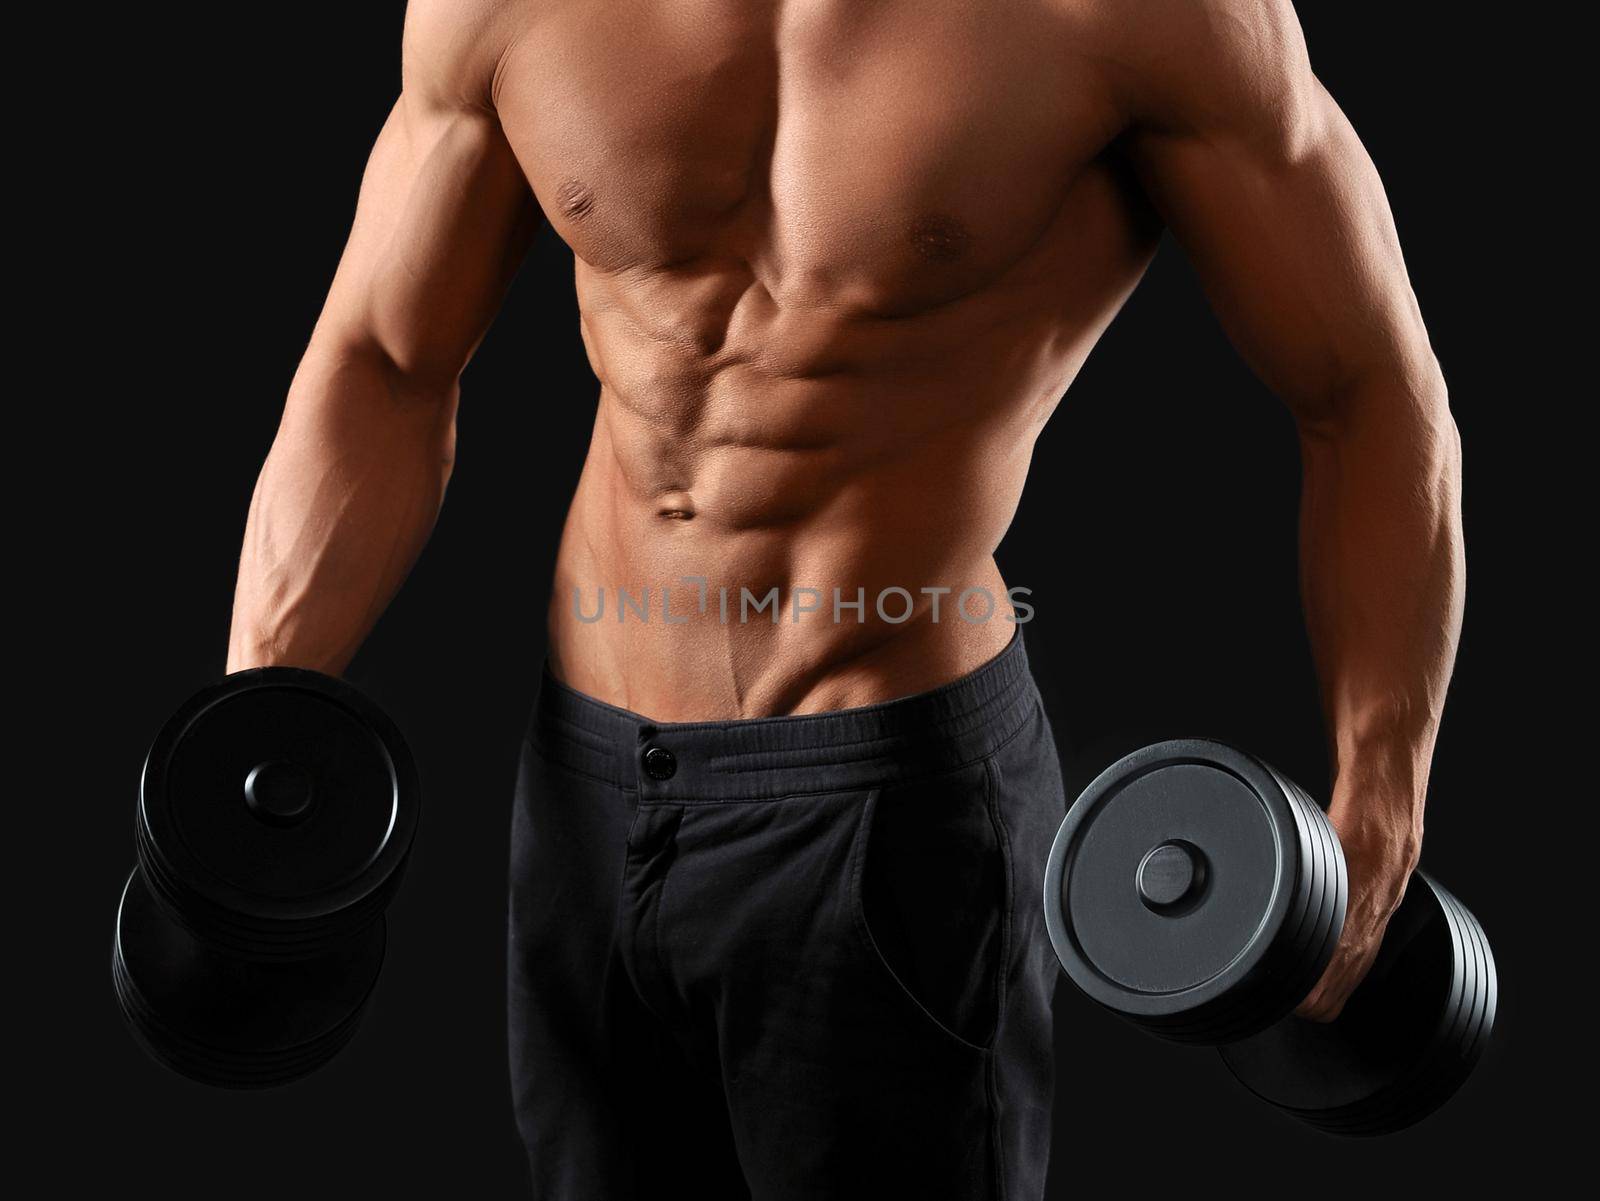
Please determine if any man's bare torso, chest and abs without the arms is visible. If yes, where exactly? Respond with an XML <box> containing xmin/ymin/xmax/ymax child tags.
<box><xmin>494</xmin><ymin>0</ymin><xmax>1158</xmax><ymax>720</ymax></box>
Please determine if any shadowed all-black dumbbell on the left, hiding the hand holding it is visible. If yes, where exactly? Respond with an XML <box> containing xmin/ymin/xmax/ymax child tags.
<box><xmin>112</xmin><ymin>667</ymin><xmax>421</xmax><ymax>1087</ymax></box>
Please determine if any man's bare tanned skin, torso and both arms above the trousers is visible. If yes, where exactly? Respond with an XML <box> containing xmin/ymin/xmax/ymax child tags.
<box><xmin>229</xmin><ymin>0</ymin><xmax>1464</xmax><ymax>1019</ymax></box>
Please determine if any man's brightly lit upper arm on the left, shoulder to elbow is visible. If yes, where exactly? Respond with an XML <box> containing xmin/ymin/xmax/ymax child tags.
<box><xmin>312</xmin><ymin>0</ymin><xmax>538</xmax><ymax>390</ymax></box>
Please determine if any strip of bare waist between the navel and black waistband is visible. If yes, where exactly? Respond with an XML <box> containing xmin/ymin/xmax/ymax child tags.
<box><xmin>549</xmin><ymin>534</ymin><xmax>1032</xmax><ymax>721</ymax></box>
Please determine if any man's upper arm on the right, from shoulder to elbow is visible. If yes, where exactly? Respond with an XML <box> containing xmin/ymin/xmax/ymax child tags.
<box><xmin>1126</xmin><ymin>0</ymin><xmax>1442</xmax><ymax>417</ymax></box>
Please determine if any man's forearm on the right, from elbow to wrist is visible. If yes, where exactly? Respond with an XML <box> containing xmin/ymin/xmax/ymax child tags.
<box><xmin>1301</xmin><ymin>371</ymin><xmax>1466</xmax><ymax>867</ymax></box>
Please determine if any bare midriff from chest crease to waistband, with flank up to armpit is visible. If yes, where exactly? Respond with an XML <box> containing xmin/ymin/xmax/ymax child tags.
<box><xmin>549</xmin><ymin>155</ymin><xmax>1154</xmax><ymax>721</ymax></box>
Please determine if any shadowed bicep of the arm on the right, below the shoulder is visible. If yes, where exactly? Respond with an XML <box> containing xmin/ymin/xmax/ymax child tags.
<box><xmin>1131</xmin><ymin>70</ymin><xmax>1435</xmax><ymax>417</ymax></box>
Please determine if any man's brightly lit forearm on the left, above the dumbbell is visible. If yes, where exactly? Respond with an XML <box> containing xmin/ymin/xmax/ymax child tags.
<box><xmin>227</xmin><ymin>341</ymin><xmax>458</xmax><ymax>673</ymax></box>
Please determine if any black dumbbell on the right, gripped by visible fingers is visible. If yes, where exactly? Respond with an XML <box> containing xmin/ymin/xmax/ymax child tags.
<box><xmin>1045</xmin><ymin>739</ymin><xmax>1498</xmax><ymax>1135</ymax></box>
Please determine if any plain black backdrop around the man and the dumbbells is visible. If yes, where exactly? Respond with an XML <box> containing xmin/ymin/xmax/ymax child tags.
<box><xmin>46</xmin><ymin>0</ymin><xmax>1561</xmax><ymax>1198</ymax></box>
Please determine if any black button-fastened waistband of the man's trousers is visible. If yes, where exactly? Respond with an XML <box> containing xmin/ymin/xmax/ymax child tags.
<box><xmin>528</xmin><ymin>630</ymin><xmax>1038</xmax><ymax>803</ymax></box>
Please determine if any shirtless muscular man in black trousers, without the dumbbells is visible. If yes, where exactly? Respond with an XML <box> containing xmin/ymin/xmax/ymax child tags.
<box><xmin>229</xmin><ymin>0</ymin><xmax>1462</xmax><ymax>1201</ymax></box>
